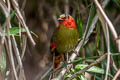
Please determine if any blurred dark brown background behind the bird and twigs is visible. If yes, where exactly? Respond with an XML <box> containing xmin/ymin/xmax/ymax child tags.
<box><xmin>18</xmin><ymin>0</ymin><xmax>120</xmax><ymax>80</ymax></box>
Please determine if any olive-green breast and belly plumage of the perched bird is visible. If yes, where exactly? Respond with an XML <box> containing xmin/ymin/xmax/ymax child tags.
<box><xmin>56</xmin><ymin>25</ymin><xmax>79</xmax><ymax>53</ymax></box>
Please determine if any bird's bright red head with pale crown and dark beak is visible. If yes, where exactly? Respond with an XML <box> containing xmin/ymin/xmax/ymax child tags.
<box><xmin>58</xmin><ymin>14</ymin><xmax>76</xmax><ymax>28</ymax></box>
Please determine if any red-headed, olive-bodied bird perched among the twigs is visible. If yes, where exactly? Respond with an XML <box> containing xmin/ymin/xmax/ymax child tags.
<box><xmin>50</xmin><ymin>14</ymin><xmax>79</xmax><ymax>68</ymax></box>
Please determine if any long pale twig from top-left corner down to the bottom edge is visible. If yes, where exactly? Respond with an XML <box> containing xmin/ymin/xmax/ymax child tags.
<box><xmin>0</xmin><ymin>0</ymin><xmax>18</xmax><ymax>80</ymax></box>
